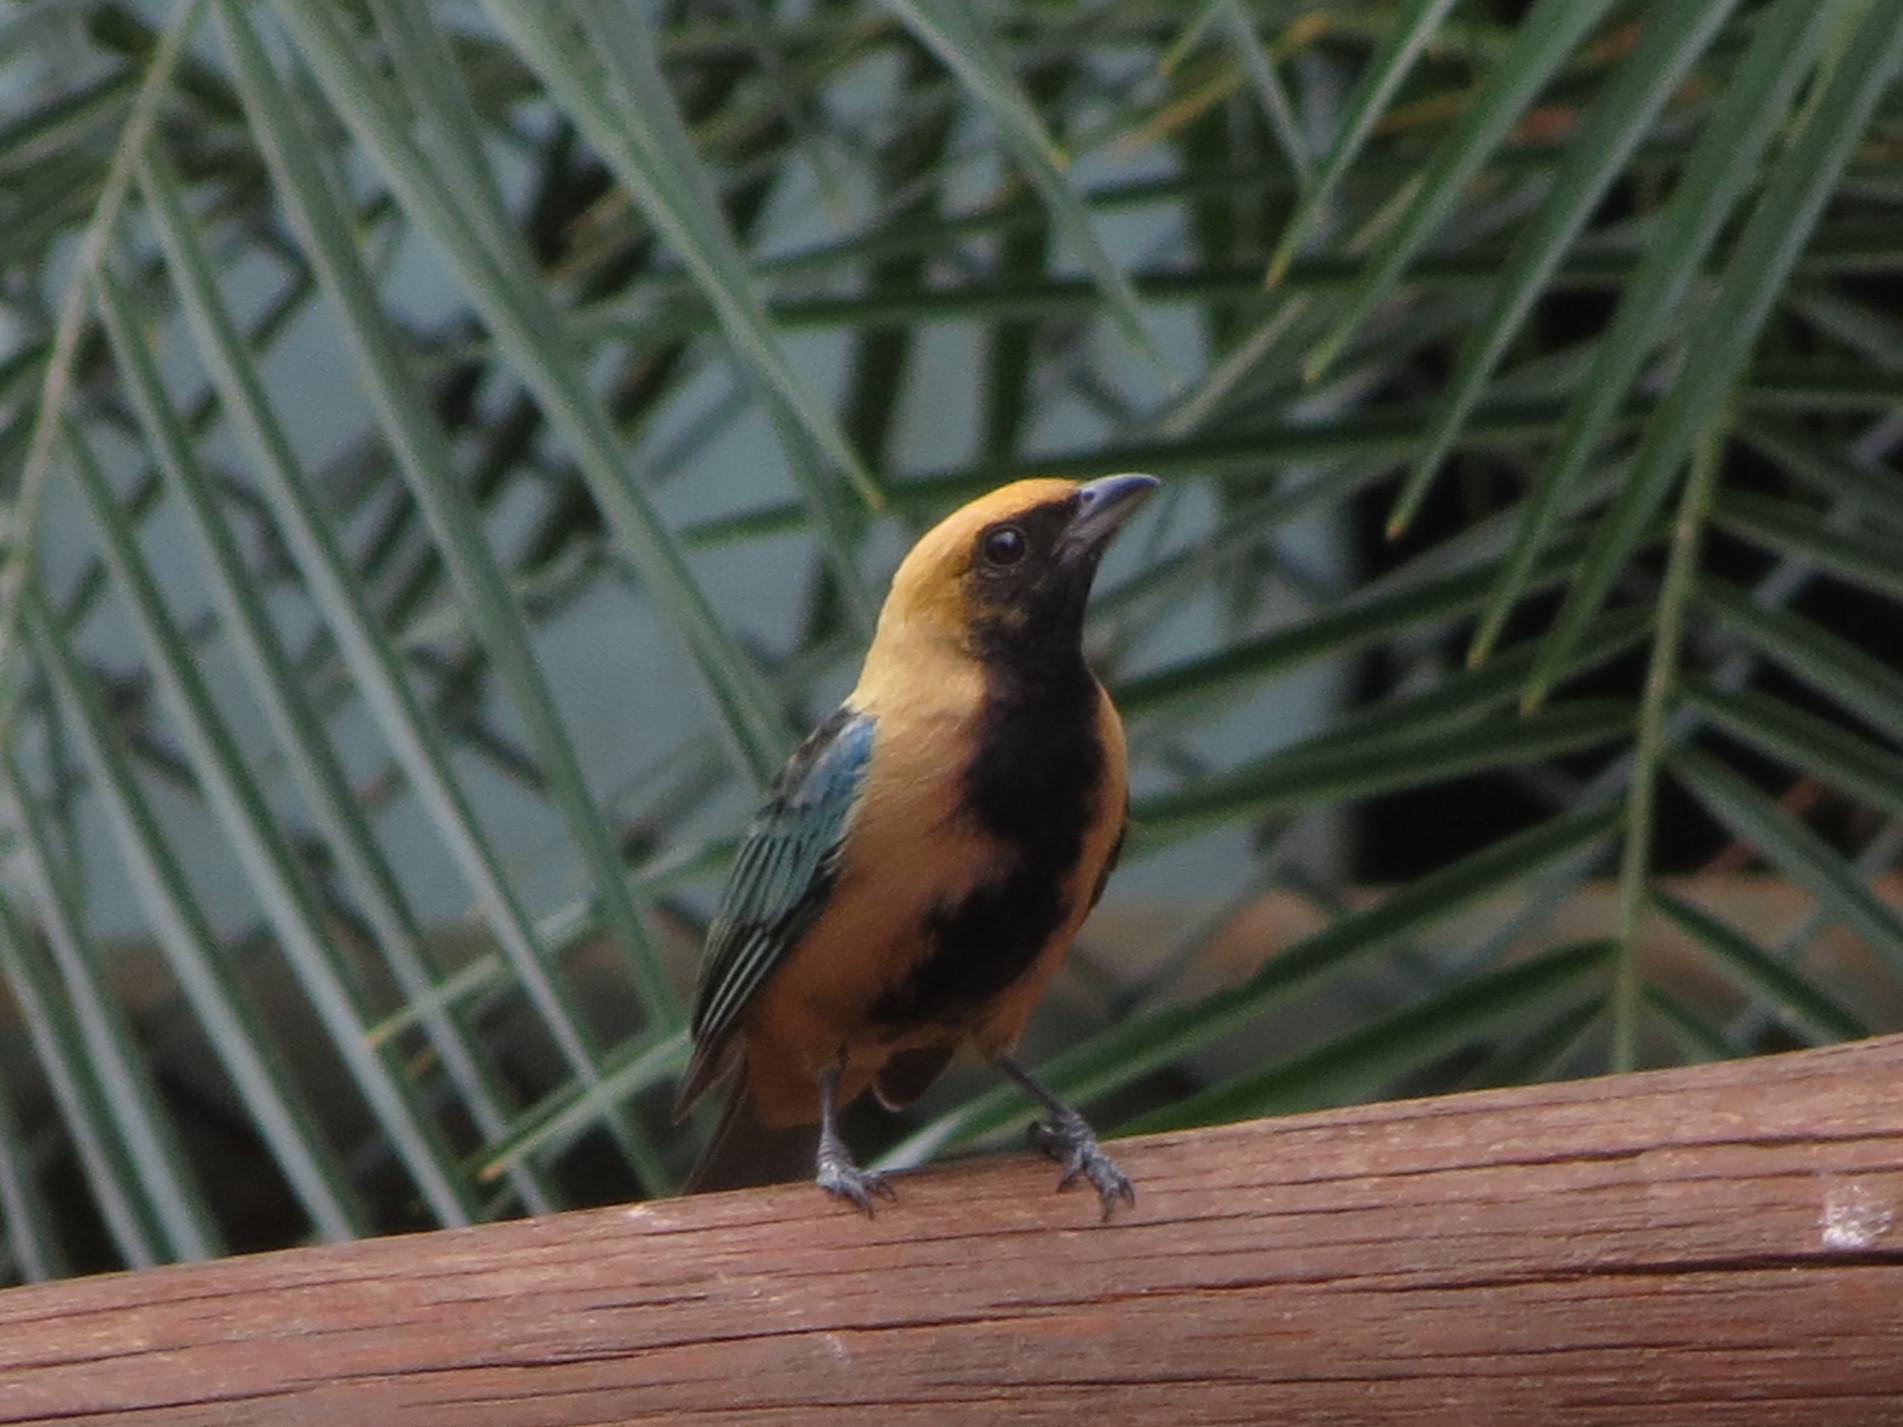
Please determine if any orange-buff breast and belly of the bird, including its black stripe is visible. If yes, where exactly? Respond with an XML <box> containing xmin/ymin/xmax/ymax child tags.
<box><xmin>761</xmin><ymin>674</ymin><xmax>1125</xmax><ymax>1043</ymax></box>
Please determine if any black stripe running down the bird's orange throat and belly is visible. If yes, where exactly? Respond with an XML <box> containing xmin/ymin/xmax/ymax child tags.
<box><xmin>873</xmin><ymin>660</ymin><xmax>1104</xmax><ymax>1027</ymax></box>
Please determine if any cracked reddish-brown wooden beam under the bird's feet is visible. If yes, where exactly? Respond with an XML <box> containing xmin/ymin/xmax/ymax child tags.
<box><xmin>0</xmin><ymin>1037</ymin><xmax>1903</xmax><ymax>1427</ymax></box>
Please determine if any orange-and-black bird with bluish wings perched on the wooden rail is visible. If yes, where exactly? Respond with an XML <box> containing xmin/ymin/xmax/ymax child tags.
<box><xmin>674</xmin><ymin>474</ymin><xmax>1157</xmax><ymax>1220</ymax></box>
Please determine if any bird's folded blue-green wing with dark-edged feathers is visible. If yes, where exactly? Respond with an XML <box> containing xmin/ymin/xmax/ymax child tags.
<box><xmin>693</xmin><ymin>708</ymin><xmax>872</xmax><ymax>1052</ymax></box>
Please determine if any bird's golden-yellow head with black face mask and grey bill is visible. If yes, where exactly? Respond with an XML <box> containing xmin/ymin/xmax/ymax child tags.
<box><xmin>879</xmin><ymin>476</ymin><xmax>1157</xmax><ymax>662</ymax></box>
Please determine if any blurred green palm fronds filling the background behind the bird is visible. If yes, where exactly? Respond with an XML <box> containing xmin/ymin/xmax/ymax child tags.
<box><xmin>0</xmin><ymin>0</ymin><xmax>1903</xmax><ymax>1279</ymax></box>
